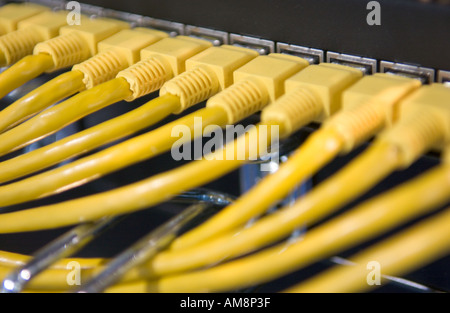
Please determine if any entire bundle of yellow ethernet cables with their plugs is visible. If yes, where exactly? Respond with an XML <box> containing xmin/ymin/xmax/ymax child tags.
<box><xmin>0</xmin><ymin>4</ymin><xmax>450</xmax><ymax>293</ymax></box>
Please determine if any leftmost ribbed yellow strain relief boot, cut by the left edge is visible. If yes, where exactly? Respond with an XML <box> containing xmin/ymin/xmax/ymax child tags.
<box><xmin>0</xmin><ymin>27</ymin><xmax>44</xmax><ymax>66</ymax></box>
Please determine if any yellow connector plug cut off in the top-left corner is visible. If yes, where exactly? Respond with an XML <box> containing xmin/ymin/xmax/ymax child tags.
<box><xmin>0</xmin><ymin>3</ymin><xmax>50</xmax><ymax>35</ymax></box>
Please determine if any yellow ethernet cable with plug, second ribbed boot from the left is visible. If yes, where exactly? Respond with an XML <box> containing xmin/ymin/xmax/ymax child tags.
<box><xmin>0</xmin><ymin>16</ymin><xmax>130</xmax><ymax>98</ymax></box>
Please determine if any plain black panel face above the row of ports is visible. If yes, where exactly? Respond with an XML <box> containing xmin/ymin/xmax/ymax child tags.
<box><xmin>82</xmin><ymin>0</ymin><xmax>450</xmax><ymax>70</ymax></box>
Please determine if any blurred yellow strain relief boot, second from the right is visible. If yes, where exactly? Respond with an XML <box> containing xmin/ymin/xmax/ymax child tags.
<box><xmin>323</xmin><ymin>97</ymin><xmax>387</xmax><ymax>154</ymax></box>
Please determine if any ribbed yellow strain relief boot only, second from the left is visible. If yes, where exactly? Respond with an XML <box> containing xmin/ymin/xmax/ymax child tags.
<box><xmin>34</xmin><ymin>32</ymin><xmax>90</xmax><ymax>72</ymax></box>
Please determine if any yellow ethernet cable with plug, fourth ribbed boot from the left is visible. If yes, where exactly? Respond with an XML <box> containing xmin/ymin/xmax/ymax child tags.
<box><xmin>0</xmin><ymin>36</ymin><xmax>212</xmax><ymax>155</ymax></box>
